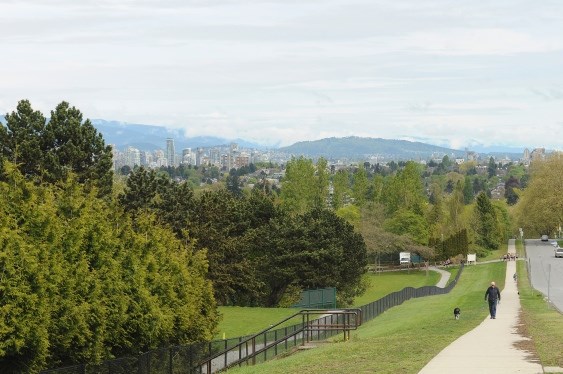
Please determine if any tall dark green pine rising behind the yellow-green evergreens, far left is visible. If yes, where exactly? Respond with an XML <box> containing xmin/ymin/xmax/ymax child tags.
<box><xmin>0</xmin><ymin>100</ymin><xmax>113</xmax><ymax>196</ymax></box>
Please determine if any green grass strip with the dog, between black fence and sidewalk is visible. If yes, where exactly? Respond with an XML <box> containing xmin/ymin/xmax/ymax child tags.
<box><xmin>229</xmin><ymin>262</ymin><xmax>506</xmax><ymax>374</ymax></box>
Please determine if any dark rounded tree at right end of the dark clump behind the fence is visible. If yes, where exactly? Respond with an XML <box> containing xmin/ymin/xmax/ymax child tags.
<box><xmin>259</xmin><ymin>209</ymin><xmax>367</xmax><ymax>306</ymax></box>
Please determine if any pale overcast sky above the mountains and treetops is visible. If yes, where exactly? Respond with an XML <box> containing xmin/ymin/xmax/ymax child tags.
<box><xmin>0</xmin><ymin>0</ymin><xmax>563</xmax><ymax>150</ymax></box>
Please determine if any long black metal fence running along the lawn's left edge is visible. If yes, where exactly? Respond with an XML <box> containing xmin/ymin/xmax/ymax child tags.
<box><xmin>41</xmin><ymin>264</ymin><xmax>463</xmax><ymax>374</ymax></box>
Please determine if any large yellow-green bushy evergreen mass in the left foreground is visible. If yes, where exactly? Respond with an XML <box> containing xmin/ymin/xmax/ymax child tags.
<box><xmin>0</xmin><ymin>163</ymin><xmax>218</xmax><ymax>373</ymax></box>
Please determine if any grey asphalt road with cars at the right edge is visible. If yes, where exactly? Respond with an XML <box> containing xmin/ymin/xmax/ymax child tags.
<box><xmin>526</xmin><ymin>239</ymin><xmax>563</xmax><ymax>313</ymax></box>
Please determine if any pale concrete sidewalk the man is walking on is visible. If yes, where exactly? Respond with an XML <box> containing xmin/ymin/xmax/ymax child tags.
<box><xmin>420</xmin><ymin>240</ymin><xmax>544</xmax><ymax>374</ymax></box>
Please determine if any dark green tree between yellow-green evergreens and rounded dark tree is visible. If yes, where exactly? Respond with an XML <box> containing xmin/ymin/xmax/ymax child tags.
<box><xmin>185</xmin><ymin>189</ymin><xmax>264</xmax><ymax>305</ymax></box>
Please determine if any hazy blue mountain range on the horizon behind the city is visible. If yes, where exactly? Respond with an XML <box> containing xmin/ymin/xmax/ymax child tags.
<box><xmin>0</xmin><ymin>116</ymin><xmax>523</xmax><ymax>160</ymax></box>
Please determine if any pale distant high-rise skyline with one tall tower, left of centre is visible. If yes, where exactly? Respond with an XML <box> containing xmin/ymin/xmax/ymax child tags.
<box><xmin>113</xmin><ymin>138</ymin><xmax>269</xmax><ymax>170</ymax></box>
